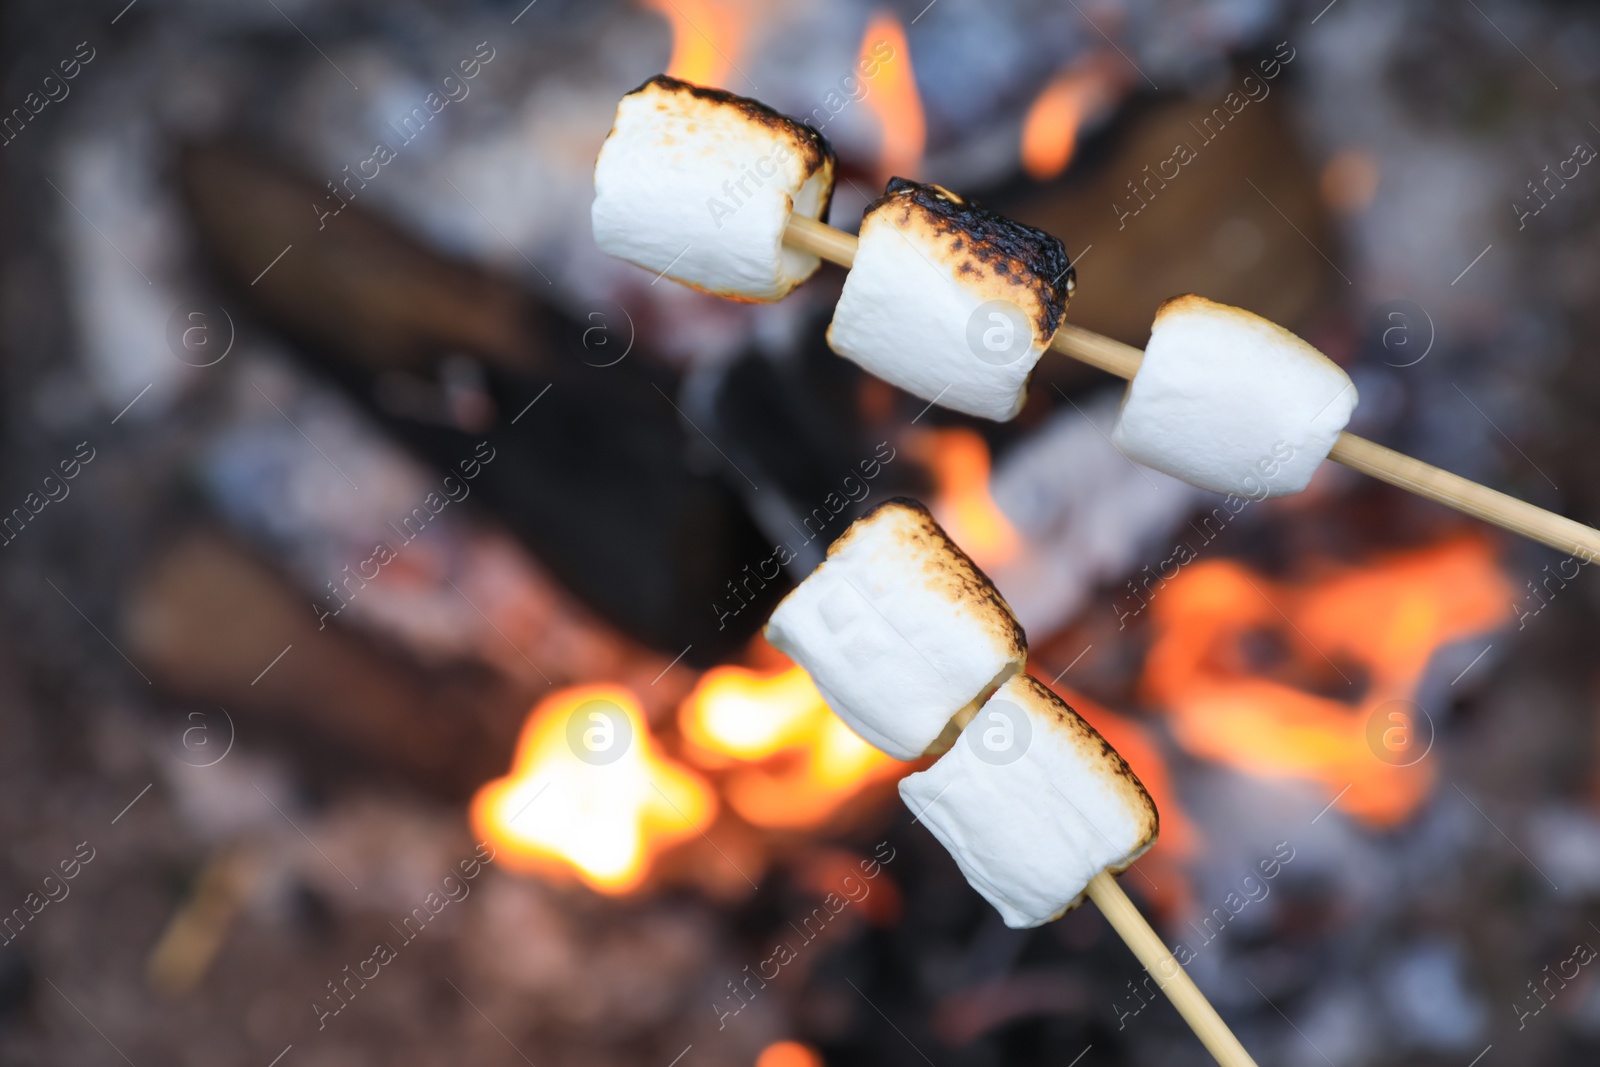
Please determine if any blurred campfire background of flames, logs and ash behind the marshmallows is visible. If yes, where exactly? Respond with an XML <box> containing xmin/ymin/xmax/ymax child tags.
<box><xmin>0</xmin><ymin>0</ymin><xmax>1600</xmax><ymax>1067</ymax></box>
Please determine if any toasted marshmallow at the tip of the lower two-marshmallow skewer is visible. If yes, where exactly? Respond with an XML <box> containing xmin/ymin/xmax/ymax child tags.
<box><xmin>766</xmin><ymin>499</ymin><xmax>1027</xmax><ymax>760</ymax></box>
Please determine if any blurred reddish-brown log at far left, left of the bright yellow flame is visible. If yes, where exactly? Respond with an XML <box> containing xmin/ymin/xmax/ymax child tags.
<box><xmin>122</xmin><ymin>530</ymin><xmax>528</xmax><ymax>797</ymax></box>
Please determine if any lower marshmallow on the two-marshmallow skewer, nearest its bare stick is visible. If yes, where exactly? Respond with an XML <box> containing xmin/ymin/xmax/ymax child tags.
<box><xmin>899</xmin><ymin>675</ymin><xmax>1158</xmax><ymax>928</ymax></box>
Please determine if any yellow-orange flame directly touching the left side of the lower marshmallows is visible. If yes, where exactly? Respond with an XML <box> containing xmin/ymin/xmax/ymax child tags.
<box><xmin>678</xmin><ymin>667</ymin><xmax>910</xmax><ymax>829</ymax></box>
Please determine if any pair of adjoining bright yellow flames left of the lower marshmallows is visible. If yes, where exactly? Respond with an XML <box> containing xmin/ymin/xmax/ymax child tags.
<box><xmin>472</xmin><ymin>641</ymin><xmax>906</xmax><ymax>894</ymax></box>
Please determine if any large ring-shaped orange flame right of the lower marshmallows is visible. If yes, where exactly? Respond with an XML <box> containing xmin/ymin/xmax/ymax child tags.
<box><xmin>1144</xmin><ymin>536</ymin><xmax>1510</xmax><ymax>825</ymax></box>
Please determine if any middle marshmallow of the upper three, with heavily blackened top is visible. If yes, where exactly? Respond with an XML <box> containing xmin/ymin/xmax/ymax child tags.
<box><xmin>827</xmin><ymin>178</ymin><xmax>1075</xmax><ymax>422</ymax></box>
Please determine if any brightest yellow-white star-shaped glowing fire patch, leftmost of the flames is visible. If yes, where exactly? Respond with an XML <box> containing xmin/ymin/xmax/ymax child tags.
<box><xmin>470</xmin><ymin>685</ymin><xmax>717</xmax><ymax>894</ymax></box>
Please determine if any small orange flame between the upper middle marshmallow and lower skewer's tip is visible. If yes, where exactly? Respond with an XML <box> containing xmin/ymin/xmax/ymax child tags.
<box><xmin>907</xmin><ymin>427</ymin><xmax>1021</xmax><ymax>569</ymax></box>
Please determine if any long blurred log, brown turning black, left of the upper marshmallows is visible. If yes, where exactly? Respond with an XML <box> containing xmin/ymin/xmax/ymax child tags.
<box><xmin>181</xmin><ymin>142</ymin><xmax>790</xmax><ymax>667</ymax></box>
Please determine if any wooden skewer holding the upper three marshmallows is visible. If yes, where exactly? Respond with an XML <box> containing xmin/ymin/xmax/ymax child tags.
<box><xmin>784</xmin><ymin>214</ymin><xmax>1600</xmax><ymax>563</ymax></box>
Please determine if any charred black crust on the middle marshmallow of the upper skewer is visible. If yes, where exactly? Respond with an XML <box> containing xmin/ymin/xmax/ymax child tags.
<box><xmin>867</xmin><ymin>178</ymin><xmax>1078</xmax><ymax>338</ymax></box>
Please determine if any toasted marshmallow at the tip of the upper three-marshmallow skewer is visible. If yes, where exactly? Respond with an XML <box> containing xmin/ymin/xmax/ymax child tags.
<box><xmin>590</xmin><ymin>74</ymin><xmax>834</xmax><ymax>302</ymax></box>
